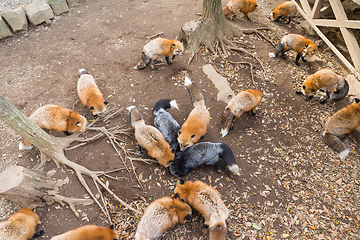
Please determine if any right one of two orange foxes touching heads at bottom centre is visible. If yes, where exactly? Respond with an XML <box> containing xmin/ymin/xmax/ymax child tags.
<box><xmin>174</xmin><ymin>180</ymin><xmax>229</xmax><ymax>240</ymax></box>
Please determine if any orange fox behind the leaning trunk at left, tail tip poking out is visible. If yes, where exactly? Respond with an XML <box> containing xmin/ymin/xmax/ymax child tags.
<box><xmin>19</xmin><ymin>104</ymin><xmax>86</xmax><ymax>150</ymax></box>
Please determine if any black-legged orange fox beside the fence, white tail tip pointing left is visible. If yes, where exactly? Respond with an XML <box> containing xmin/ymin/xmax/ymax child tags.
<box><xmin>269</xmin><ymin>34</ymin><xmax>317</xmax><ymax>66</ymax></box>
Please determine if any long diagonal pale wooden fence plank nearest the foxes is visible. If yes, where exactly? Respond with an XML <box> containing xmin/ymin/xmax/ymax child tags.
<box><xmin>291</xmin><ymin>0</ymin><xmax>360</xmax><ymax>74</ymax></box>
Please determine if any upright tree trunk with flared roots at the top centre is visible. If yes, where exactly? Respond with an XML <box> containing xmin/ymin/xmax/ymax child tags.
<box><xmin>177</xmin><ymin>0</ymin><xmax>243</xmax><ymax>64</ymax></box>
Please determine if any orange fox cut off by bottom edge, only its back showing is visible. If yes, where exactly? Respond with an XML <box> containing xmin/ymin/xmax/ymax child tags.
<box><xmin>50</xmin><ymin>225</ymin><xmax>118</xmax><ymax>240</ymax></box>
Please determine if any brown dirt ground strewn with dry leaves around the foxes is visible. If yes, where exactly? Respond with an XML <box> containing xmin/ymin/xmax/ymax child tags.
<box><xmin>0</xmin><ymin>0</ymin><xmax>360</xmax><ymax>239</ymax></box>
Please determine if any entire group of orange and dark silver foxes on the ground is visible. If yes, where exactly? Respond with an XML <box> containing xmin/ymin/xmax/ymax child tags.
<box><xmin>0</xmin><ymin>0</ymin><xmax>360</xmax><ymax>240</ymax></box>
